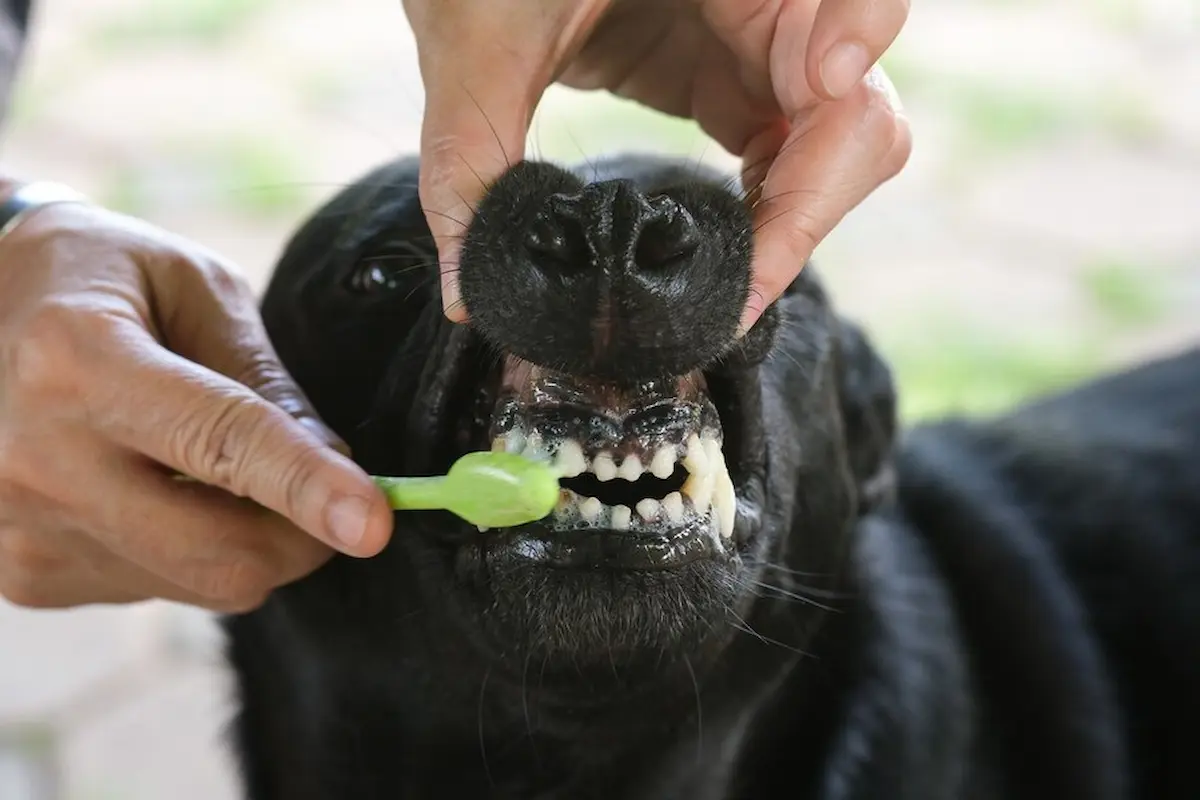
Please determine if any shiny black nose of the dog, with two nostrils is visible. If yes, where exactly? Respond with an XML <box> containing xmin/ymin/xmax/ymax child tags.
<box><xmin>526</xmin><ymin>181</ymin><xmax>700</xmax><ymax>280</ymax></box>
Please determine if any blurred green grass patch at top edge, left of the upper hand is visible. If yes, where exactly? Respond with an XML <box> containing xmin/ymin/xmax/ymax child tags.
<box><xmin>92</xmin><ymin>0</ymin><xmax>276</xmax><ymax>52</ymax></box>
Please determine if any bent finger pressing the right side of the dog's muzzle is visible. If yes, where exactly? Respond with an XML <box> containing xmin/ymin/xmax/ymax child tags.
<box><xmin>740</xmin><ymin>74</ymin><xmax>912</xmax><ymax>332</ymax></box>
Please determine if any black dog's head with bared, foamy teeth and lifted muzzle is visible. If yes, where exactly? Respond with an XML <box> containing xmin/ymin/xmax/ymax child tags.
<box><xmin>263</xmin><ymin>157</ymin><xmax>893</xmax><ymax>680</ymax></box>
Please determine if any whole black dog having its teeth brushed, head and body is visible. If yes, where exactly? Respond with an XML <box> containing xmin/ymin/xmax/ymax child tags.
<box><xmin>227</xmin><ymin>153</ymin><xmax>1200</xmax><ymax>800</ymax></box>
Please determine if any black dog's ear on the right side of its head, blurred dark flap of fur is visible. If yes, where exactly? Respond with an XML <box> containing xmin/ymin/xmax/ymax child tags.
<box><xmin>838</xmin><ymin>318</ymin><xmax>896</xmax><ymax>513</ymax></box>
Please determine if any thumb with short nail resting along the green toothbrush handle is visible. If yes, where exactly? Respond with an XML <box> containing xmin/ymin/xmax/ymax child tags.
<box><xmin>79</xmin><ymin>324</ymin><xmax>392</xmax><ymax>555</ymax></box>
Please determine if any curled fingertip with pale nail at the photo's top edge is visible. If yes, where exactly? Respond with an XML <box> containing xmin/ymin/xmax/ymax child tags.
<box><xmin>805</xmin><ymin>0</ymin><xmax>910</xmax><ymax>100</ymax></box>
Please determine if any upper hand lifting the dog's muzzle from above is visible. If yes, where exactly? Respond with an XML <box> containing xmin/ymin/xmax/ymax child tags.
<box><xmin>404</xmin><ymin>0</ymin><xmax>912</xmax><ymax>331</ymax></box>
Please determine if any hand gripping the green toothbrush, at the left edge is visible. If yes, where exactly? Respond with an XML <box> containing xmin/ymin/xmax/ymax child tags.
<box><xmin>0</xmin><ymin>195</ymin><xmax>391</xmax><ymax>612</ymax></box>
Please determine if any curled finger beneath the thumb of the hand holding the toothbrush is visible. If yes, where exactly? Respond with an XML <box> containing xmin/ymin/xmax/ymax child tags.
<box><xmin>25</xmin><ymin>440</ymin><xmax>331</xmax><ymax>607</ymax></box>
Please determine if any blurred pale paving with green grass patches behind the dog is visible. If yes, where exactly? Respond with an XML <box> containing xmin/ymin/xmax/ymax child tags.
<box><xmin>0</xmin><ymin>0</ymin><xmax>1200</xmax><ymax>800</ymax></box>
